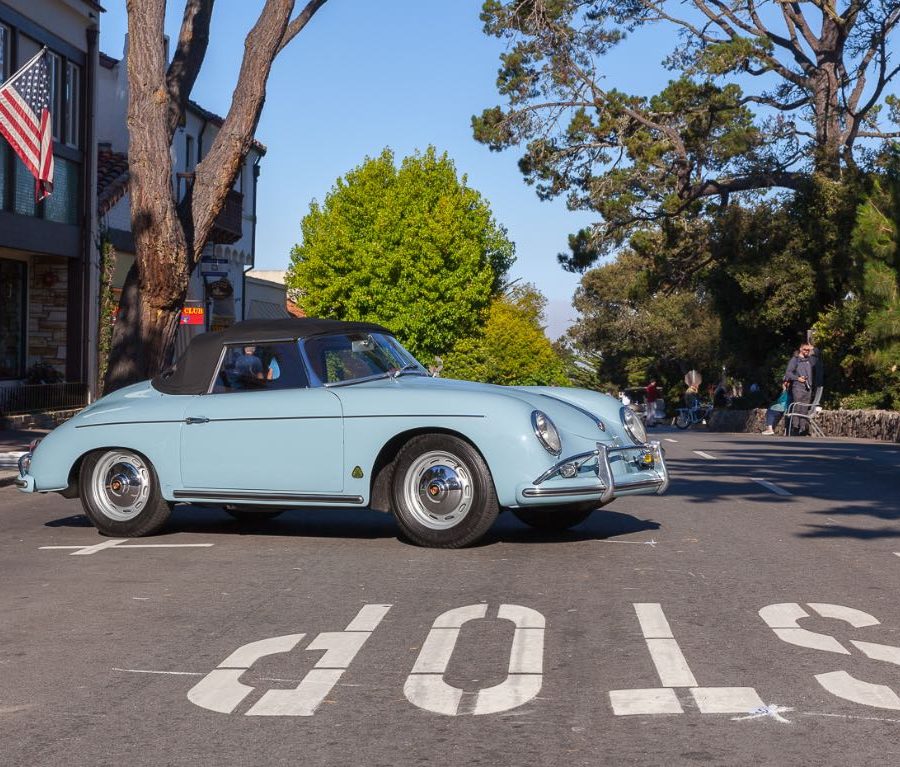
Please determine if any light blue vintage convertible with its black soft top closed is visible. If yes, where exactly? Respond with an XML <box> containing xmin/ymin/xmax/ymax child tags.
<box><xmin>17</xmin><ymin>318</ymin><xmax>668</xmax><ymax>548</ymax></box>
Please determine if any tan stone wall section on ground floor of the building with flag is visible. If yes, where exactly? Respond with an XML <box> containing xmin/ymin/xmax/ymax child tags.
<box><xmin>26</xmin><ymin>256</ymin><xmax>69</xmax><ymax>373</ymax></box>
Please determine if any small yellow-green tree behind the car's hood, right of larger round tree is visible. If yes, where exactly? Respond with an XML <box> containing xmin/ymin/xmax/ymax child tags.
<box><xmin>442</xmin><ymin>284</ymin><xmax>569</xmax><ymax>386</ymax></box>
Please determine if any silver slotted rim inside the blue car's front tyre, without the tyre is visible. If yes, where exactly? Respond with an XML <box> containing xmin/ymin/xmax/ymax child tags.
<box><xmin>403</xmin><ymin>450</ymin><xmax>473</xmax><ymax>530</ymax></box>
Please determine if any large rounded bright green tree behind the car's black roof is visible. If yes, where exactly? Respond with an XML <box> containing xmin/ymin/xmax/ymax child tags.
<box><xmin>286</xmin><ymin>147</ymin><xmax>514</xmax><ymax>361</ymax></box>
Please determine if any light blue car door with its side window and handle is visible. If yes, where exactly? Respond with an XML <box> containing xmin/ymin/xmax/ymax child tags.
<box><xmin>181</xmin><ymin>341</ymin><xmax>344</xmax><ymax>502</ymax></box>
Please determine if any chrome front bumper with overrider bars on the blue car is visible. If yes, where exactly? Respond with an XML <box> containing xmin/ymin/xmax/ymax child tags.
<box><xmin>522</xmin><ymin>442</ymin><xmax>669</xmax><ymax>504</ymax></box>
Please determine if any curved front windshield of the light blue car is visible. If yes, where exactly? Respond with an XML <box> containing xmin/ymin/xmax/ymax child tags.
<box><xmin>303</xmin><ymin>333</ymin><xmax>428</xmax><ymax>386</ymax></box>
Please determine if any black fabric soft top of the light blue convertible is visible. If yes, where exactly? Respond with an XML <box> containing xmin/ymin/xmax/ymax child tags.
<box><xmin>150</xmin><ymin>317</ymin><xmax>392</xmax><ymax>394</ymax></box>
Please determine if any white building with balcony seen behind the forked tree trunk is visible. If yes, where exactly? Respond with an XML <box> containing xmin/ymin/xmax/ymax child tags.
<box><xmin>97</xmin><ymin>40</ymin><xmax>266</xmax><ymax>362</ymax></box>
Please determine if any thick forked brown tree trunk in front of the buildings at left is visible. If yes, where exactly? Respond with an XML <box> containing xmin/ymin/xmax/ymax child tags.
<box><xmin>104</xmin><ymin>0</ymin><xmax>326</xmax><ymax>392</ymax></box>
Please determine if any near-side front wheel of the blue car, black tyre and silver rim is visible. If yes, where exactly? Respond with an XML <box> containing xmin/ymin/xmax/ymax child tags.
<box><xmin>391</xmin><ymin>434</ymin><xmax>500</xmax><ymax>549</ymax></box>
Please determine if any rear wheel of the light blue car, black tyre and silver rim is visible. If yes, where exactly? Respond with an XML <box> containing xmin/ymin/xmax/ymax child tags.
<box><xmin>78</xmin><ymin>449</ymin><xmax>172</xmax><ymax>538</ymax></box>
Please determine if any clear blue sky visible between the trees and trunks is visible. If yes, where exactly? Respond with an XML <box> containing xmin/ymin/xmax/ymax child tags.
<box><xmin>100</xmin><ymin>0</ymin><xmax>668</xmax><ymax>337</ymax></box>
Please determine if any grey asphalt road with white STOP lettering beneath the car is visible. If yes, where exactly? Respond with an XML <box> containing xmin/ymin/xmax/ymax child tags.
<box><xmin>0</xmin><ymin>428</ymin><xmax>900</xmax><ymax>767</ymax></box>
